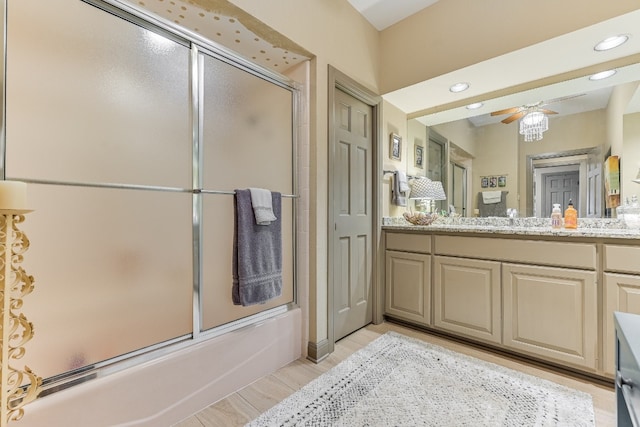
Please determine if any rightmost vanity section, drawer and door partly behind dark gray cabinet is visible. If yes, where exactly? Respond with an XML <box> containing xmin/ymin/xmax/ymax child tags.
<box><xmin>603</xmin><ymin>245</ymin><xmax>640</xmax><ymax>377</ymax></box>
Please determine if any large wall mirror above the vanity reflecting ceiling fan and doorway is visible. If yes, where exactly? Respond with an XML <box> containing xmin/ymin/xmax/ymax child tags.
<box><xmin>408</xmin><ymin>64</ymin><xmax>640</xmax><ymax>217</ymax></box>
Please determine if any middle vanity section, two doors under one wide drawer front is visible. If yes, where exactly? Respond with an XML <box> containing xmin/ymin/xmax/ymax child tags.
<box><xmin>433</xmin><ymin>235</ymin><xmax>598</xmax><ymax>371</ymax></box>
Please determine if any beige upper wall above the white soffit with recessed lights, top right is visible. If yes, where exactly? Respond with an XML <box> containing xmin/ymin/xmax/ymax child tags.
<box><xmin>380</xmin><ymin>0</ymin><xmax>640</xmax><ymax>93</ymax></box>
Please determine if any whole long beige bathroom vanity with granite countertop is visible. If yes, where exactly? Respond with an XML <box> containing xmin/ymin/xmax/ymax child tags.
<box><xmin>383</xmin><ymin>222</ymin><xmax>640</xmax><ymax>379</ymax></box>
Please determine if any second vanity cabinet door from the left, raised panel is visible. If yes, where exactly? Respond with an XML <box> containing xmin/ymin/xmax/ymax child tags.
<box><xmin>433</xmin><ymin>256</ymin><xmax>501</xmax><ymax>343</ymax></box>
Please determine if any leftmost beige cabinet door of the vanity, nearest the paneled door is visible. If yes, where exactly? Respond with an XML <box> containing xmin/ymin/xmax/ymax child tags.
<box><xmin>385</xmin><ymin>251</ymin><xmax>431</xmax><ymax>325</ymax></box>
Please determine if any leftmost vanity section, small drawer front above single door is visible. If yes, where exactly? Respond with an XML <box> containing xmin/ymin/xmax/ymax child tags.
<box><xmin>385</xmin><ymin>233</ymin><xmax>431</xmax><ymax>326</ymax></box>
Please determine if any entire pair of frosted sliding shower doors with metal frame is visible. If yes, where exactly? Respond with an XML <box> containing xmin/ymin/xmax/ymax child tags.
<box><xmin>0</xmin><ymin>0</ymin><xmax>295</xmax><ymax>392</ymax></box>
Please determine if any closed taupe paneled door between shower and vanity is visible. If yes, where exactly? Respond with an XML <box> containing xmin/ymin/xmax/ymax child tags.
<box><xmin>330</xmin><ymin>89</ymin><xmax>373</xmax><ymax>341</ymax></box>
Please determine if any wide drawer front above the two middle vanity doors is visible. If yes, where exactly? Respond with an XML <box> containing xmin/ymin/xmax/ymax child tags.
<box><xmin>434</xmin><ymin>236</ymin><xmax>597</xmax><ymax>270</ymax></box>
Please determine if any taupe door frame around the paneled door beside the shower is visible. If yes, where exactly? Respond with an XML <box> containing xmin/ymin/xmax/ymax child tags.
<box><xmin>328</xmin><ymin>65</ymin><xmax>384</xmax><ymax>360</ymax></box>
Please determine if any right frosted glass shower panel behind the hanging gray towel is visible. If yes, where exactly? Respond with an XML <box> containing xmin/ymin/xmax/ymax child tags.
<box><xmin>200</xmin><ymin>49</ymin><xmax>295</xmax><ymax>330</ymax></box>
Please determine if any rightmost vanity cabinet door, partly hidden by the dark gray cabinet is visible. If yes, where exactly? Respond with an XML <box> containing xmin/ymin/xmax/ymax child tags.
<box><xmin>602</xmin><ymin>273</ymin><xmax>640</xmax><ymax>377</ymax></box>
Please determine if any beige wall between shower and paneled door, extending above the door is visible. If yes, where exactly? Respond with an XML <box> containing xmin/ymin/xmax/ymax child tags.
<box><xmin>226</xmin><ymin>0</ymin><xmax>386</xmax><ymax>343</ymax></box>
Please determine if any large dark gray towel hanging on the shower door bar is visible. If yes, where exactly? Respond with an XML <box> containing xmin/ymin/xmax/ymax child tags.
<box><xmin>231</xmin><ymin>190</ymin><xmax>282</xmax><ymax>306</ymax></box>
